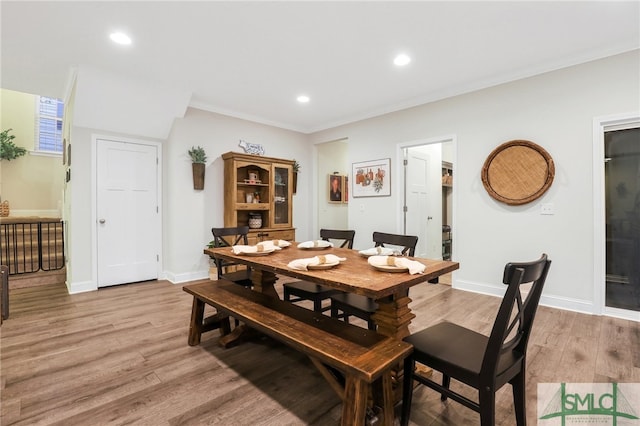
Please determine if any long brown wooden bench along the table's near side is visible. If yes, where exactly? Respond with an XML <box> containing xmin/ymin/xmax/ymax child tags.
<box><xmin>183</xmin><ymin>280</ymin><xmax>413</xmax><ymax>426</ymax></box>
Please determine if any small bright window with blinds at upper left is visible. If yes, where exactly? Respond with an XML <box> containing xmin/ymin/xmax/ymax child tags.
<box><xmin>36</xmin><ymin>96</ymin><xmax>64</xmax><ymax>154</ymax></box>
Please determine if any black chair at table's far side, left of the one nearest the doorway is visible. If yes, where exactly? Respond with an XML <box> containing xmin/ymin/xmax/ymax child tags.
<box><xmin>283</xmin><ymin>229</ymin><xmax>356</xmax><ymax>312</ymax></box>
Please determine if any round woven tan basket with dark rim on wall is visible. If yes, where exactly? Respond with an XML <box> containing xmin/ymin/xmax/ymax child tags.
<box><xmin>482</xmin><ymin>140</ymin><xmax>556</xmax><ymax>205</ymax></box>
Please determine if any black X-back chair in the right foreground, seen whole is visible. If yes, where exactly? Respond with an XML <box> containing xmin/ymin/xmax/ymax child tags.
<box><xmin>401</xmin><ymin>254</ymin><xmax>551</xmax><ymax>426</ymax></box>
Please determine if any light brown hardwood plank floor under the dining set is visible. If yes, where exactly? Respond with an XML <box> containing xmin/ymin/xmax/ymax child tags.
<box><xmin>0</xmin><ymin>281</ymin><xmax>640</xmax><ymax>426</ymax></box>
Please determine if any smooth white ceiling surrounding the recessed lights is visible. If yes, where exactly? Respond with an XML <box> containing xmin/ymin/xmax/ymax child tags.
<box><xmin>0</xmin><ymin>0</ymin><xmax>640</xmax><ymax>133</ymax></box>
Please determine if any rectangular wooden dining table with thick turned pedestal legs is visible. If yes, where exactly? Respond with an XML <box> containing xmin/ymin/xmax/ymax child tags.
<box><xmin>204</xmin><ymin>242</ymin><xmax>459</xmax><ymax>340</ymax></box>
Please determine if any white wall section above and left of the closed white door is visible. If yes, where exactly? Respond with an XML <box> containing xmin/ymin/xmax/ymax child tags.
<box><xmin>64</xmin><ymin>66</ymin><xmax>190</xmax><ymax>293</ymax></box>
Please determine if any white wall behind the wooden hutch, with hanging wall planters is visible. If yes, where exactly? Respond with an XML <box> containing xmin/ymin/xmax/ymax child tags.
<box><xmin>163</xmin><ymin>108</ymin><xmax>313</xmax><ymax>282</ymax></box>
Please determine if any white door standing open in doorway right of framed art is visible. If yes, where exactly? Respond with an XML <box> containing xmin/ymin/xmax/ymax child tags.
<box><xmin>405</xmin><ymin>144</ymin><xmax>442</xmax><ymax>259</ymax></box>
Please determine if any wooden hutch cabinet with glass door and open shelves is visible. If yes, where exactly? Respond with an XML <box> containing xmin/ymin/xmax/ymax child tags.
<box><xmin>222</xmin><ymin>152</ymin><xmax>295</xmax><ymax>245</ymax></box>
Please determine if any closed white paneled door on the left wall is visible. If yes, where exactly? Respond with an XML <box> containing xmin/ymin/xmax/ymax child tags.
<box><xmin>96</xmin><ymin>139</ymin><xmax>161</xmax><ymax>287</ymax></box>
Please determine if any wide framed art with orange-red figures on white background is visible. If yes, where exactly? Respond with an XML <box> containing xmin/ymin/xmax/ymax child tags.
<box><xmin>351</xmin><ymin>158</ymin><xmax>391</xmax><ymax>198</ymax></box>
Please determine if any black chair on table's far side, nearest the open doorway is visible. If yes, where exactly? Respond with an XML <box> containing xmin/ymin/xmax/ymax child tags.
<box><xmin>331</xmin><ymin>232</ymin><xmax>418</xmax><ymax>330</ymax></box>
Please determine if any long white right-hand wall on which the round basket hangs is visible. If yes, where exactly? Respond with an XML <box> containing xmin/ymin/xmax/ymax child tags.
<box><xmin>311</xmin><ymin>50</ymin><xmax>640</xmax><ymax>312</ymax></box>
